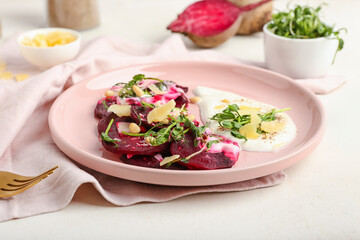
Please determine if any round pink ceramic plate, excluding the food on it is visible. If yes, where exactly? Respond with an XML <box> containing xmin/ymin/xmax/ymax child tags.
<box><xmin>49</xmin><ymin>62</ymin><xmax>325</xmax><ymax>186</ymax></box>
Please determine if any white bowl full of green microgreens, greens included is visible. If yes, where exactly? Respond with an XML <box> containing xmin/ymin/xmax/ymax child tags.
<box><xmin>263</xmin><ymin>5</ymin><xmax>346</xmax><ymax>79</ymax></box>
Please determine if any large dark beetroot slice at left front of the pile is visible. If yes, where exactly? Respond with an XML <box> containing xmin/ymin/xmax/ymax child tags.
<box><xmin>98</xmin><ymin>114</ymin><xmax>170</xmax><ymax>155</ymax></box>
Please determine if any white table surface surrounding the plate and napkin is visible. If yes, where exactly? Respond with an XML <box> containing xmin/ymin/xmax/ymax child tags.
<box><xmin>0</xmin><ymin>0</ymin><xmax>360</xmax><ymax>240</ymax></box>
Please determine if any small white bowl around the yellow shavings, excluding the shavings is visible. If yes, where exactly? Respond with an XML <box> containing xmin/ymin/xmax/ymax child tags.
<box><xmin>17</xmin><ymin>28</ymin><xmax>81</xmax><ymax>69</ymax></box>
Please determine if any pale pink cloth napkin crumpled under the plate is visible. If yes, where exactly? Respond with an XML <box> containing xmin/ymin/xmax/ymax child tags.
<box><xmin>0</xmin><ymin>32</ymin><xmax>340</xmax><ymax>221</ymax></box>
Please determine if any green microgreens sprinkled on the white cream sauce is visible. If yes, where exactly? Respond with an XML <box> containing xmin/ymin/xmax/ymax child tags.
<box><xmin>210</xmin><ymin>104</ymin><xmax>291</xmax><ymax>141</ymax></box>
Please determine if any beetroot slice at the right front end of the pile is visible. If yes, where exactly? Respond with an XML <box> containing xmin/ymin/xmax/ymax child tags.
<box><xmin>170</xmin><ymin>133</ymin><xmax>236</xmax><ymax>170</ymax></box>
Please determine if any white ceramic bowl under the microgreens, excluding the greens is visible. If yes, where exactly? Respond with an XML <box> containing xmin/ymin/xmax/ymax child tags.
<box><xmin>263</xmin><ymin>23</ymin><xmax>338</xmax><ymax>79</ymax></box>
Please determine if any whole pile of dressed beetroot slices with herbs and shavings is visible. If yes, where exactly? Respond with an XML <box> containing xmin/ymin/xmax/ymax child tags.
<box><xmin>94</xmin><ymin>74</ymin><xmax>240</xmax><ymax>170</ymax></box>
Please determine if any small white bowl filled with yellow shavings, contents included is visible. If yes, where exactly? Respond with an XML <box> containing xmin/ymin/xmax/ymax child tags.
<box><xmin>17</xmin><ymin>28</ymin><xmax>81</xmax><ymax>69</ymax></box>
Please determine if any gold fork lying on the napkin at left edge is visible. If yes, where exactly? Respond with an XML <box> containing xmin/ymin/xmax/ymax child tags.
<box><xmin>0</xmin><ymin>166</ymin><xmax>58</xmax><ymax>198</ymax></box>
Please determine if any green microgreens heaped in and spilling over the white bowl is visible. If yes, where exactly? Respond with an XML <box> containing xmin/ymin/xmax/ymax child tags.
<box><xmin>268</xmin><ymin>5</ymin><xmax>347</xmax><ymax>63</ymax></box>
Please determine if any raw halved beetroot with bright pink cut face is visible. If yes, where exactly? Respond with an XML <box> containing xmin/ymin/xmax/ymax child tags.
<box><xmin>167</xmin><ymin>0</ymin><xmax>271</xmax><ymax>47</ymax></box>
